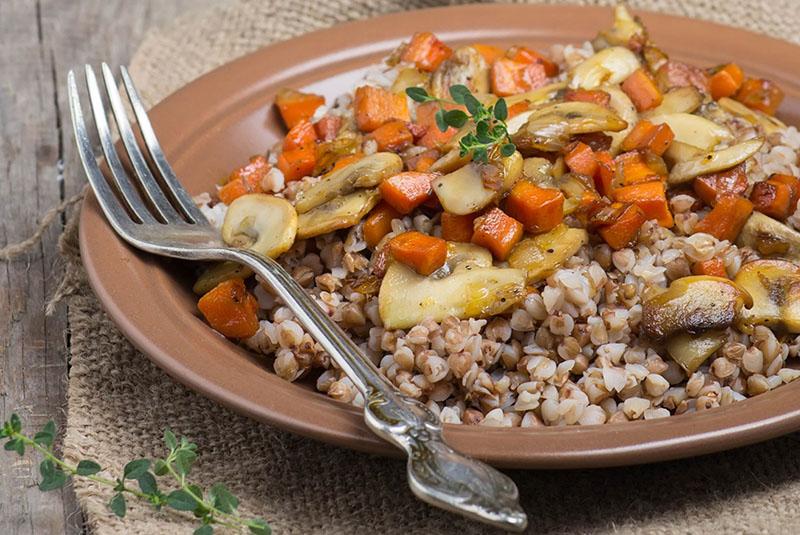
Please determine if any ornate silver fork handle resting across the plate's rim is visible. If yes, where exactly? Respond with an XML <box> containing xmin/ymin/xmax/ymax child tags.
<box><xmin>225</xmin><ymin>249</ymin><xmax>527</xmax><ymax>531</ymax></box>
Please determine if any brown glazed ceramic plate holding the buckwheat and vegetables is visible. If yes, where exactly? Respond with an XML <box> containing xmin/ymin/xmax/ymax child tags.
<box><xmin>80</xmin><ymin>5</ymin><xmax>800</xmax><ymax>468</ymax></box>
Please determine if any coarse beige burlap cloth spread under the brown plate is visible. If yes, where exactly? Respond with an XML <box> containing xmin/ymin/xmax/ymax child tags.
<box><xmin>62</xmin><ymin>0</ymin><xmax>800</xmax><ymax>534</ymax></box>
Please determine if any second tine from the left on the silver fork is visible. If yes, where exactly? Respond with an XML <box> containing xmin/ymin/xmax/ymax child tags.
<box><xmin>85</xmin><ymin>65</ymin><xmax>156</xmax><ymax>223</ymax></box>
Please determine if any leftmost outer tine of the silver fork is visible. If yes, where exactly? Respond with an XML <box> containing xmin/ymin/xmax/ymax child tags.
<box><xmin>67</xmin><ymin>71</ymin><xmax>133</xmax><ymax>237</ymax></box>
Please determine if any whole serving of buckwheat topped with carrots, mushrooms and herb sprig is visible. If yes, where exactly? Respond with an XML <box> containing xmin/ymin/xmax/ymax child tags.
<box><xmin>195</xmin><ymin>5</ymin><xmax>800</xmax><ymax>426</ymax></box>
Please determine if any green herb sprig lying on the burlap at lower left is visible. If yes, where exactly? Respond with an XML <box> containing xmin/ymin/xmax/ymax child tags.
<box><xmin>0</xmin><ymin>414</ymin><xmax>271</xmax><ymax>535</ymax></box>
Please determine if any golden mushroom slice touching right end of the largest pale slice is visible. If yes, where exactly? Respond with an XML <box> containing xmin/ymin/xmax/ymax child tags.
<box><xmin>508</xmin><ymin>223</ymin><xmax>589</xmax><ymax>284</ymax></box>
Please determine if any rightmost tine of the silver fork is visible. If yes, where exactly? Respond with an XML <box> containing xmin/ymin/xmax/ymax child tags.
<box><xmin>120</xmin><ymin>66</ymin><xmax>208</xmax><ymax>224</ymax></box>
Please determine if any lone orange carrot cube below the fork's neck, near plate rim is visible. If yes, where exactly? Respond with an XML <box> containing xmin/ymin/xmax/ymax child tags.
<box><xmin>197</xmin><ymin>278</ymin><xmax>258</xmax><ymax>338</ymax></box>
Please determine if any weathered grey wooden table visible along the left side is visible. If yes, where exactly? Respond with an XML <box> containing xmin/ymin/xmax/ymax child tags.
<box><xmin>0</xmin><ymin>0</ymin><xmax>213</xmax><ymax>535</ymax></box>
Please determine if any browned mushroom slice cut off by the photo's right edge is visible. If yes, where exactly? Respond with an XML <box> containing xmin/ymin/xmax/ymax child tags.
<box><xmin>736</xmin><ymin>260</ymin><xmax>800</xmax><ymax>333</ymax></box>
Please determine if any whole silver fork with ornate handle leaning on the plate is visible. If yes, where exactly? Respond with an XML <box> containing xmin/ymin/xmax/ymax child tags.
<box><xmin>67</xmin><ymin>63</ymin><xmax>528</xmax><ymax>531</ymax></box>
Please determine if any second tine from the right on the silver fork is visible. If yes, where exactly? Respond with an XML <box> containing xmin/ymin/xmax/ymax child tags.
<box><xmin>102</xmin><ymin>63</ymin><xmax>183</xmax><ymax>223</ymax></box>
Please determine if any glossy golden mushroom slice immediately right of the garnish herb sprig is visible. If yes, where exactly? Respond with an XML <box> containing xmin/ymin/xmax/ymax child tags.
<box><xmin>511</xmin><ymin>102</ymin><xmax>628</xmax><ymax>152</ymax></box>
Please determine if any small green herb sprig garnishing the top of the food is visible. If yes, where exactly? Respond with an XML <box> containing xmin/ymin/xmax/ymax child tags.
<box><xmin>406</xmin><ymin>84</ymin><xmax>517</xmax><ymax>163</ymax></box>
